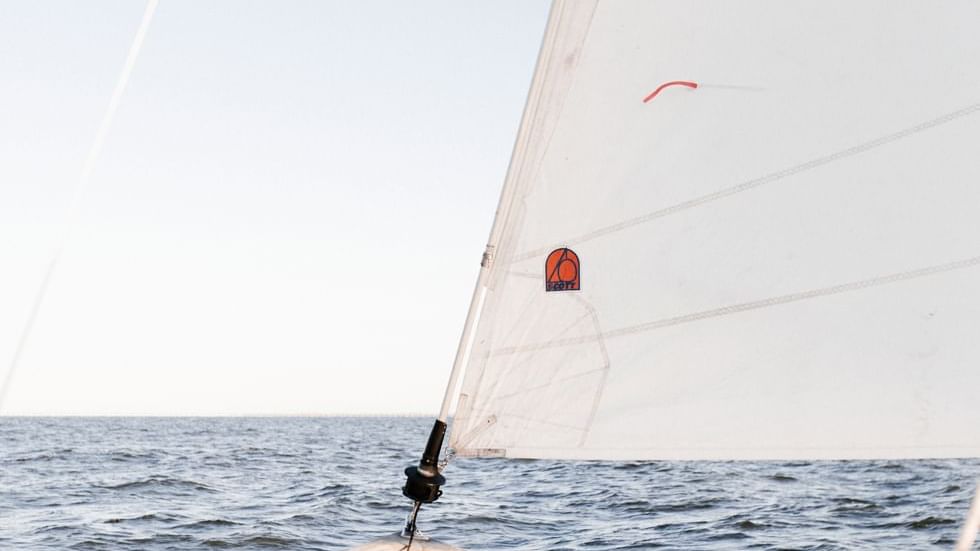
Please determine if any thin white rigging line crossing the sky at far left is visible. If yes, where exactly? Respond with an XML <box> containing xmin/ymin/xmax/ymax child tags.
<box><xmin>0</xmin><ymin>0</ymin><xmax>159</xmax><ymax>413</ymax></box>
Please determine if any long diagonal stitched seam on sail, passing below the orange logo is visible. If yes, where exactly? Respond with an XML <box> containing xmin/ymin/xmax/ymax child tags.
<box><xmin>486</xmin><ymin>256</ymin><xmax>980</xmax><ymax>357</ymax></box>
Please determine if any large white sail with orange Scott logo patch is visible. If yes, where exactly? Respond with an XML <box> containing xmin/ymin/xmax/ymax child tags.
<box><xmin>450</xmin><ymin>0</ymin><xmax>980</xmax><ymax>459</ymax></box>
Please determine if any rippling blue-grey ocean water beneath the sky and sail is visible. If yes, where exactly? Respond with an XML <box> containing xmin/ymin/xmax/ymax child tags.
<box><xmin>0</xmin><ymin>418</ymin><xmax>980</xmax><ymax>551</ymax></box>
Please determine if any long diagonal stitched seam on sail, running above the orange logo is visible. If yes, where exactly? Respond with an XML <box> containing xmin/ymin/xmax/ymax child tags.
<box><xmin>501</xmin><ymin>103</ymin><xmax>980</xmax><ymax>264</ymax></box>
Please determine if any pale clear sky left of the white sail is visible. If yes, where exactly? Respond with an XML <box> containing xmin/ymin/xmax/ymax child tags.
<box><xmin>0</xmin><ymin>0</ymin><xmax>548</xmax><ymax>415</ymax></box>
